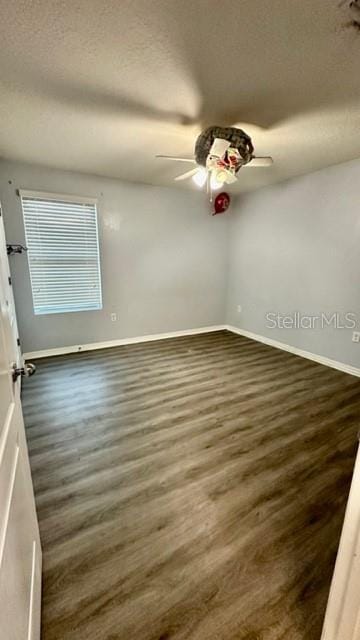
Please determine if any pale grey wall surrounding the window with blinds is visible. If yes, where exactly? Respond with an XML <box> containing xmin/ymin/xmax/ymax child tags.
<box><xmin>0</xmin><ymin>162</ymin><xmax>228</xmax><ymax>352</ymax></box>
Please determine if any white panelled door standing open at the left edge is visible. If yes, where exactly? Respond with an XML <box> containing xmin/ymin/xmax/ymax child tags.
<box><xmin>0</xmin><ymin>207</ymin><xmax>41</xmax><ymax>640</ymax></box>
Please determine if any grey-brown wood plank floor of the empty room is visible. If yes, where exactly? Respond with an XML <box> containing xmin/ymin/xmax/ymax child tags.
<box><xmin>23</xmin><ymin>332</ymin><xmax>360</xmax><ymax>640</ymax></box>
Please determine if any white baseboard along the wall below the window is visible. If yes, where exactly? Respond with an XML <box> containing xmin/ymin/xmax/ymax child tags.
<box><xmin>24</xmin><ymin>324</ymin><xmax>227</xmax><ymax>360</ymax></box>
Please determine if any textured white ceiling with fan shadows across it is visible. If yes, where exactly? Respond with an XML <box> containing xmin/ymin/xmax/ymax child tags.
<box><xmin>0</xmin><ymin>0</ymin><xmax>360</xmax><ymax>191</ymax></box>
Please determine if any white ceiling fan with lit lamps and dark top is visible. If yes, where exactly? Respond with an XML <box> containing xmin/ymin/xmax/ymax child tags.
<box><xmin>156</xmin><ymin>126</ymin><xmax>274</xmax><ymax>194</ymax></box>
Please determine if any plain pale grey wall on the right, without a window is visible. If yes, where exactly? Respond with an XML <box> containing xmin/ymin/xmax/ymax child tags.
<box><xmin>227</xmin><ymin>160</ymin><xmax>360</xmax><ymax>367</ymax></box>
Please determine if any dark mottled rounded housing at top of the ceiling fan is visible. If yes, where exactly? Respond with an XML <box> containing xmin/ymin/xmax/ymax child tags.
<box><xmin>195</xmin><ymin>126</ymin><xmax>254</xmax><ymax>170</ymax></box>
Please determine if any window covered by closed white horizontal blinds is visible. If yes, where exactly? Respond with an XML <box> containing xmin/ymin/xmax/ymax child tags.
<box><xmin>20</xmin><ymin>191</ymin><xmax>102</xmax><ymax>315</ymax></box>
